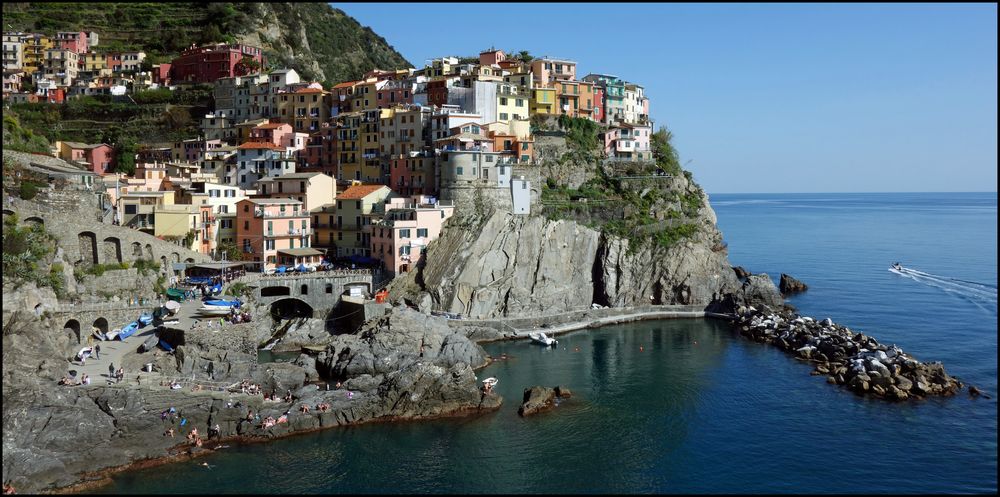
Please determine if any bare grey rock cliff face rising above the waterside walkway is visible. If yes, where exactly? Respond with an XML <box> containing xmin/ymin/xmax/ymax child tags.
<box><xmin>390</xmin><ymin>165</ymin><xmax>781</xmax><ymax>318</ymax></box>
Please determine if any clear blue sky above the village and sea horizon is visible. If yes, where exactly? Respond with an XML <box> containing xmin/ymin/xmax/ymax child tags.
<box><xmin>332</xmin><ymin>2</ymin><xmax>997</xmax><ymax>193</ymax></box>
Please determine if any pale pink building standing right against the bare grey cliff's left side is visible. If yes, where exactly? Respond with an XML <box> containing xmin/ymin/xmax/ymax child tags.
<box><xmin>366</xmin><ymin>195</ymin><xmax>455</xmax><ymax>274</ymax></box>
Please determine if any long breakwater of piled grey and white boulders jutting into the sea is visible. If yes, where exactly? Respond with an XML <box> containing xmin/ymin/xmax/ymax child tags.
<box><xmin>734</xmin><ymin>306</ymin><xmax>974</xmax><ymax>401</ymax></box>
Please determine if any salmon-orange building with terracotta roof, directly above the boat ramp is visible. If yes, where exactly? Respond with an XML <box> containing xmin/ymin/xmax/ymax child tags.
<box><xmin>236</xmin><ymin>199</ymin><xmax>323</xmax><ymax>271</ymax></box>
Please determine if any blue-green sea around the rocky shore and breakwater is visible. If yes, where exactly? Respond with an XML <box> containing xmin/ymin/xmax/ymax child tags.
<box><xmin>98</xmin><ymin>193</ymin><xmax>997</xmax><ymax>494</ymax></box>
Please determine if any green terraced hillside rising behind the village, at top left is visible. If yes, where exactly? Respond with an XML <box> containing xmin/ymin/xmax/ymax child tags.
<box><xmin>3</xmin><ymin>2</ymin><xmax>410</xmax><ymax>83</ymax></box>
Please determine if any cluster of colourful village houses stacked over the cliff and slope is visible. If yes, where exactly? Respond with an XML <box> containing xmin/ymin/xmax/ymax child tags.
<box><xmin>3</xmin><ymin>32</ymin><xmax>652</xmax><ymax>275</ymax></box>
